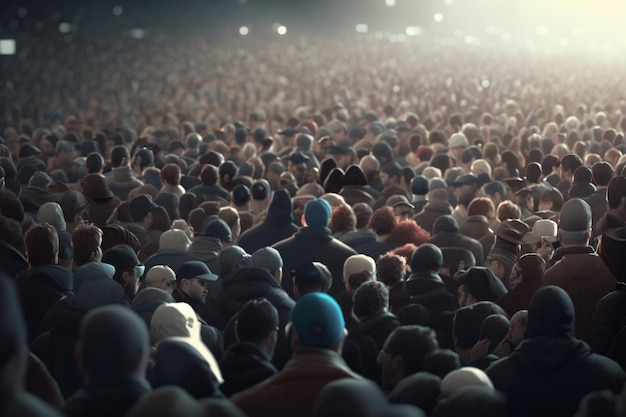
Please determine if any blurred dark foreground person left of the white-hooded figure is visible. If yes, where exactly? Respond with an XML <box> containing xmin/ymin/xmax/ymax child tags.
<box><xmin>63</xmin><ymin>305</ymin><xmax>151</xmax><ymax>417</ymax></box>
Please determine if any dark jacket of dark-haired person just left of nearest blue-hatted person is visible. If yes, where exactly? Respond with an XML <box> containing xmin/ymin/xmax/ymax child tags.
<box><xmin>220</xmin><ymin>342</ymin><xmax>278</xmax><ymax>397</ymax></box>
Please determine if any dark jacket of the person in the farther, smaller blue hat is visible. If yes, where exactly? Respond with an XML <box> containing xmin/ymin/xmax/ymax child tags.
<box><xmin>273</xmin><ymin>227</ymin><xmax>356</xmax><ymax>296</ymax></box>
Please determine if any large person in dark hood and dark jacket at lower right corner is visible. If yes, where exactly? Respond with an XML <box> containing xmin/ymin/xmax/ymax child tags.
<box><xmin>486</xmin><ymin>286</ymin><xmax>626</xmax><ymax>417</ymax></box>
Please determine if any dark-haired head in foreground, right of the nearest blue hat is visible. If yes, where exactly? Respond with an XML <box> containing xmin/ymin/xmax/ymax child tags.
<box><xmin>378</xmin><ymin>325</ymin><xmax>439</xmax><ymax>390</ymax></box>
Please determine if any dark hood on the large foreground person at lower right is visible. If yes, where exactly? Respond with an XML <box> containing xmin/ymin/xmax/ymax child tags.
<box><xmin>526</xmin><ymin>285</ymin><xmax>574</xmax><ymax>339</ymax></box>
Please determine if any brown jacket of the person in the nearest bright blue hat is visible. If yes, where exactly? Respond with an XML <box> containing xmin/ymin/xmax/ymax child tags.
<box><xmin>231</xmin><ymin>348</ymin><xmax>363</xmax><ymax>417</ymax></box>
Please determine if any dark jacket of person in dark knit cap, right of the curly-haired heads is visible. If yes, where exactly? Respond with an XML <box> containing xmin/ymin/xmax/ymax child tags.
<box><xmin>389</xmin><ymin>271</ymin><xmax>459</xmax><ymax>314</ymax></box>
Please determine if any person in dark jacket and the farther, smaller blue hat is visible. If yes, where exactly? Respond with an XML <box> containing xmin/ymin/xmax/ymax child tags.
<box><xmin>272</xmin><ymin>198</ymin><xmax>356</xmax><ymax>296</ymax></box>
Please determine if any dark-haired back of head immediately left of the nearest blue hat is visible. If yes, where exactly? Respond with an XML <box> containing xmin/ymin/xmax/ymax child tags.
<box><xmin>235</xmin><ymin>298</ymin><xmax>278</xmax><ymax>343</ymax></box>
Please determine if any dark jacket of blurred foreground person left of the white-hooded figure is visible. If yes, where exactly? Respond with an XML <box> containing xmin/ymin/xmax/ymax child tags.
<box><xmin>63</xmin><ymin>377</ymin><xmax>151</xmax><ymax>417</ymax></box>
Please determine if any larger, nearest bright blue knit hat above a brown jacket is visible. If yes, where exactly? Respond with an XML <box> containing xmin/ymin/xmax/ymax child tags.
<box><xmin>289</xmin><ymin>293</ymin><xmax>345</xmax><ymax>348</ymax></box>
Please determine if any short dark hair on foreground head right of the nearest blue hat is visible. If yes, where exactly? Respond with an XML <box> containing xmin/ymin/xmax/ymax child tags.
<box><xmin>386</xmin><ymin>325</ymin><xmax>439</xmax><ymax>375</ymax></box>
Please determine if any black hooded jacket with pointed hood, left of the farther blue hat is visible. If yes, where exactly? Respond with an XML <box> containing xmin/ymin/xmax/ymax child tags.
<box><xmin>237</xmin><ymin>190</ymin><xmax>300</xmax><ymax>253</ymax></box>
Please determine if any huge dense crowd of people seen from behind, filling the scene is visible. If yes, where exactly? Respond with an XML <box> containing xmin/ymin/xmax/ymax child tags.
<box><xmin>0</xmin><ymin>4</ymin><xmax>626</xmax><ymax>417</ymax></box>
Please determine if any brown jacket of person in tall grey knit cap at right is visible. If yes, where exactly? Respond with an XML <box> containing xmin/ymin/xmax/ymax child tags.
<box><xmin>543</xmin><ymin>246</ymin><xmax>617</xmax><ymax>343</ymax></box>
